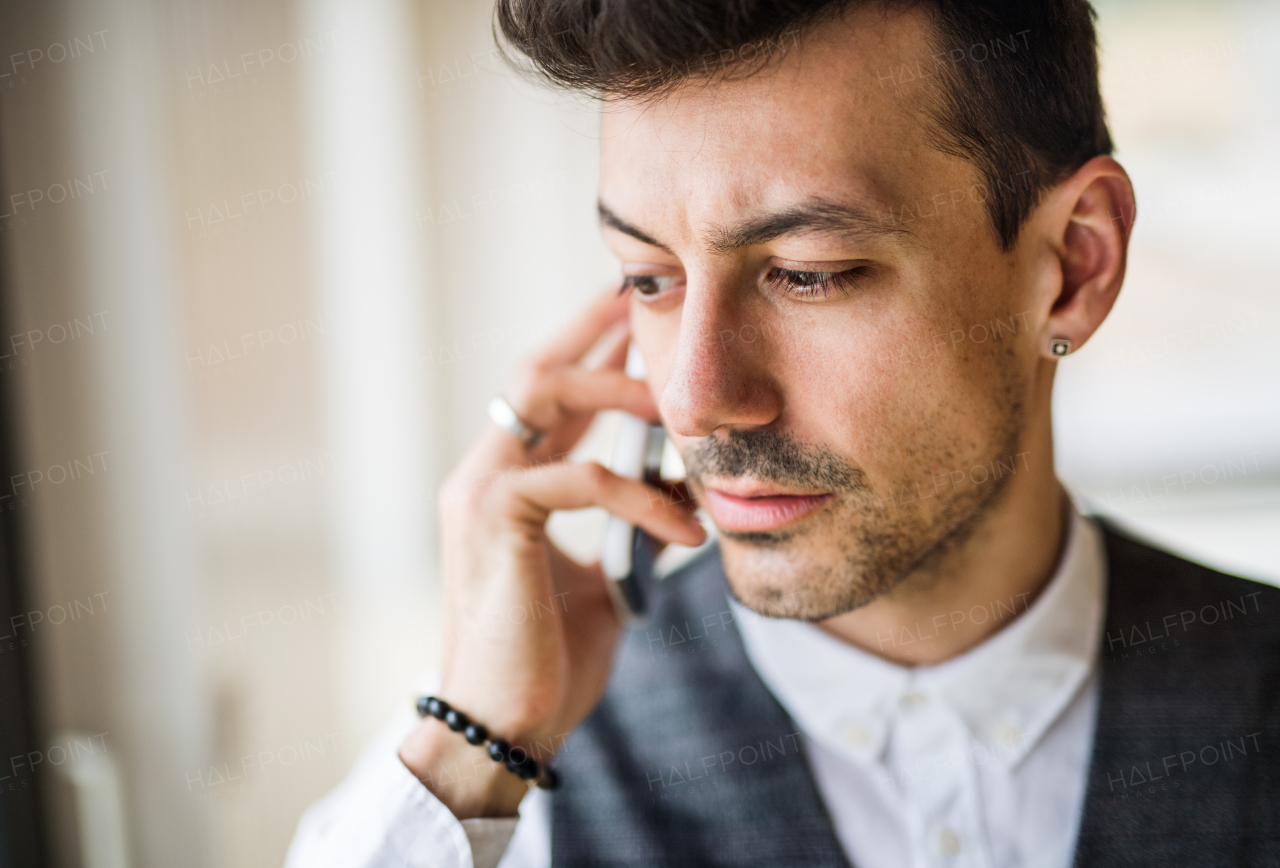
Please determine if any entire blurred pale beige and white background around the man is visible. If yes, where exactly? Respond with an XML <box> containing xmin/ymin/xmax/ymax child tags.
<box><xmin>0</xmin><ymin>0</ymin><xmax>1280</xmax><ymax>868</ymax></box>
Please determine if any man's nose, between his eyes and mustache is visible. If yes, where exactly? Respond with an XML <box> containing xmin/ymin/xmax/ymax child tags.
<box><xmin>658</xmin><ymin>275</ymin><xmax>782</xmax><ymax>437</ymax></box>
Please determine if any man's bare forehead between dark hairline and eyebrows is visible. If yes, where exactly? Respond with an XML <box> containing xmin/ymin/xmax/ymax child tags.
<box><xmin>600</xmin><ymin>8</ymin><xmax>955</xmax><ymax>234</ymax></box>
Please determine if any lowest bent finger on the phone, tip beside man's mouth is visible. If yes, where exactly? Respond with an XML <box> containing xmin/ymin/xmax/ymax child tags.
<box><xmin>512</xmin><ymin>462</ymin><xmax>707</xmax><ymax>545</ymax></box>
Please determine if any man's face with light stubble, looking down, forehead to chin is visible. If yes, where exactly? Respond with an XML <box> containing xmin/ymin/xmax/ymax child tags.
<box><xmin>600</xmin><ymin>10</ymin><xmax>1043</xmax><ymax>620</ymax></box>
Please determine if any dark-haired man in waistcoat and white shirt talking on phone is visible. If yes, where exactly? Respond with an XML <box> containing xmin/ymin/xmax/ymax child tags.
<box><xmin>291</xmin><ymin>0</ymin><xmax>1280</xmax><ymax>868</ymax></box>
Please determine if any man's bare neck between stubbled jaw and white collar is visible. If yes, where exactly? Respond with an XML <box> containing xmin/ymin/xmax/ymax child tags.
<box><xmin>818</xmin><ymin>446</ymin><xmax>1070</xmax><ymax>666</ymax></box>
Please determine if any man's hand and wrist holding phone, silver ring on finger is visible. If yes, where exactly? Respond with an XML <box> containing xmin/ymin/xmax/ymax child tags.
<box><xmin>401</xmin><ymin>292</ymin><xmax>705</xmax><ymax>819</ymax></box>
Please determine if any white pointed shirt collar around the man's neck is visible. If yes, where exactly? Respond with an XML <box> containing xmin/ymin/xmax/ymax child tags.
<box><xmin>730</xmin><ymin>507</ymin><xmax>1106</xmax><ymax>769</ymax></box>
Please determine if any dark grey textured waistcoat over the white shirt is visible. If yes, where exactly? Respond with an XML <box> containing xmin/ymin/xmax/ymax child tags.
<box><xmin>552</xmin><ymin>527</ymin><xmax>1280</xmax><ymax>868</ymax></box>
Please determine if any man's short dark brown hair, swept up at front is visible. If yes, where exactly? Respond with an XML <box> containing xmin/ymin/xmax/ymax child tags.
<box><xmin>494</xmin><ymin>0</ymin><xmax>1112</xmax><ymax>251</ymax></box>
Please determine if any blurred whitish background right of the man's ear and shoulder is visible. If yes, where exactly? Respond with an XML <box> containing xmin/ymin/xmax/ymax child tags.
<box><xmin>1055</xmin><ymin>3</ymin><xmax>1280</xmax><ymax>583</ymax></box>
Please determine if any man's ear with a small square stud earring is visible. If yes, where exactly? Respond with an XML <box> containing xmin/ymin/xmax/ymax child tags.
<box><xmin>1038</xmin><ymin>156</ymin><xmax>1137</xmax><ymax>358</ymax></box>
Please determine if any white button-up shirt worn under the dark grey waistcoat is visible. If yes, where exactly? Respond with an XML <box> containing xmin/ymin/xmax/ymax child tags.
<box><xmin>285</xmin><ymin>511</ymin><xmax>1106</xmax><ymax>868</ymax></box>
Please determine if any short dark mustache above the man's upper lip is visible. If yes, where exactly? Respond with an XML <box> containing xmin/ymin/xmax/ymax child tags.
<box><xmin>684</xmin><ymin>429</ymin><xmax>869</xmax><ymax>492</ymax></box>
